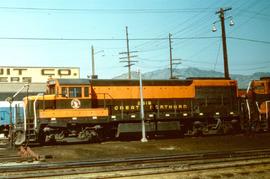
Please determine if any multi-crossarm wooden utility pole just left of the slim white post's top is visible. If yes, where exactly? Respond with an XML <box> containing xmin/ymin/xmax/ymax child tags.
<box><xmin>119</xmin><ymin>26</ymin><xmax>138</xmax><ymax>80</ymax></box>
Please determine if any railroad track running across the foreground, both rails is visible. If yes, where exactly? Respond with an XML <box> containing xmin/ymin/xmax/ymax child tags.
<box><xmin>0</xmin><ymin>149</ymin><xmax>270</xmax><ymax>178</ymax></box>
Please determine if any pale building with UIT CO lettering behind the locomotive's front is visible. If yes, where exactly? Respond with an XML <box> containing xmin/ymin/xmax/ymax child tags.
<box><xmin>0</xmin><ymin>66</ymin><xmax>80</xmax><ymax>101</ymax></box>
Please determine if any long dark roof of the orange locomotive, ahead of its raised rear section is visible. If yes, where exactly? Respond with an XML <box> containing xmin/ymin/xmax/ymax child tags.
<box><xmin>51</xmin><ymin>78</ymin><xmax>192</xmax><ymax>86</ymax></box>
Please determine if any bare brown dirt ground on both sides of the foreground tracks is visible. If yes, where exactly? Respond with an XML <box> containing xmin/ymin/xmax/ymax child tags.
<box><xmin>0</xmin><ymin>133</ymin><xmax>270</xmax><ymax>179</ymax></box>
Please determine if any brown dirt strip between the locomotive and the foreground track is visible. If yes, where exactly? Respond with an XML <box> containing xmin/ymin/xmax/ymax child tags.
<box><xmin>22</xmin><ymin>133</ymin><xmax>270</xmax><ymax>162</ymax></box>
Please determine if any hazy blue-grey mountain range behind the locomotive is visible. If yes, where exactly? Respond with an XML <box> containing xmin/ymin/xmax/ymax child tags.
<box><xmin>113</xmin><ymin>67</ymin><xmax>270</xmax><ymax>89</ymax></box>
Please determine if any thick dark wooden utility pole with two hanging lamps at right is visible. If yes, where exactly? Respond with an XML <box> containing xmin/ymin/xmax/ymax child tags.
<box><xmin>216</xmin><ymin>8</ymin><xmax>232</xmax><ymax>79</ymax></box>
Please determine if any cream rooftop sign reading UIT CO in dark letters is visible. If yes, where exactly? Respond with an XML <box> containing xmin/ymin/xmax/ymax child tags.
<box><xmin>0</xmin><ymin>67</ymin><xmax>80</xmax><ymax>83</ymax></box>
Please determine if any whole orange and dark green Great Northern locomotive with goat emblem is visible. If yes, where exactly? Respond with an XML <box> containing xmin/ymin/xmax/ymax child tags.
<box><xmin>15</xmin><ymin>78</ymin><xmax>241</xmax><ymax>144</ymax></box>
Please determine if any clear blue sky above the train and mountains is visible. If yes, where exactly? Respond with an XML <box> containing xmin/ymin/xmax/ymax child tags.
<box><xmin>0</xmin><ymin>0</ymin><xmax>270</xmax><ymax>78</ymax></box>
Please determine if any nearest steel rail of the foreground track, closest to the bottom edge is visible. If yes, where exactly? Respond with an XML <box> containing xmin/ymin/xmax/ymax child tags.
<box><xmin>4</xmin><ymin>157</ymin><xmax>270</xmax><ymax>178</ymax></box>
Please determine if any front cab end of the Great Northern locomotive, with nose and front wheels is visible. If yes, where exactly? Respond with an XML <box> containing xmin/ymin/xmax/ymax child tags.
<box><xmin>14</xmin><ymin>79</ymin><xmax>108</xmax><ymax>144</ymax></box>
